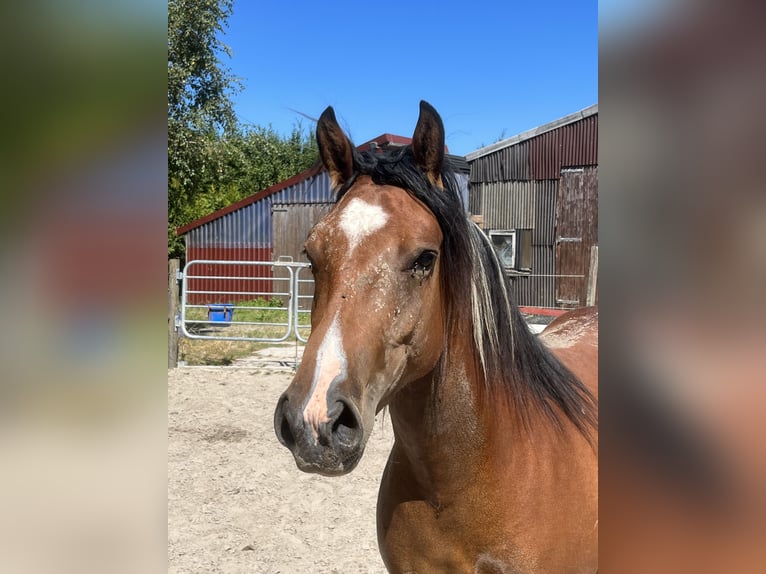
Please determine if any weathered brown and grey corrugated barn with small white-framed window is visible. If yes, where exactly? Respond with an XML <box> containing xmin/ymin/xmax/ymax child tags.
<box><xmin>466</xmin><ymin>104</ymin><xmax>598</xmax><ymax>308</ymax></box>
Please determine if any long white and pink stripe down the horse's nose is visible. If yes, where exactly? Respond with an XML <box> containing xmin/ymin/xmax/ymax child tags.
<box><xmin>303</xmin><ymin>314</ymin><xmax>346</xmax><ymax>442</ymax></box>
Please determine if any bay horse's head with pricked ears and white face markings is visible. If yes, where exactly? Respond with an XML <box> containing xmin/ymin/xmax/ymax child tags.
<box><xmin>274</xmin><ymin>102</ymin><xmax>450</xmax><ymax>475</ymax></box>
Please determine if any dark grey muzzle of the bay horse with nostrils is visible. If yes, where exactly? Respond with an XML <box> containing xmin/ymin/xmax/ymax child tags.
<box><xmin>274</xmin><ymin>393</ymin><xmax>365</xmax><ymax>476</ymax></box>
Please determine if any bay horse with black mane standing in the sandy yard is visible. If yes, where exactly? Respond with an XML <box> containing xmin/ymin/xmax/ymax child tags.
<box><xmin>274</xmin><ymin>102</ymin><xmax>598</xmax><ymax>574</ymax></box>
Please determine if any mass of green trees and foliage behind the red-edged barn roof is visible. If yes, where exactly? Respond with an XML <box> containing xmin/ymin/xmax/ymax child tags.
<box><xmin>168</xmin><ymin>0</ymin><xmax>318</xmax><ymax>257</ymax></box>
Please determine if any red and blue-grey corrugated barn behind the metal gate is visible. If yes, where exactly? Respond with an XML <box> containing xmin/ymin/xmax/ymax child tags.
<box><xmin>176</xmin><ymin>134</ymin><xmax>469</xmax><ymax>304</ymax></box>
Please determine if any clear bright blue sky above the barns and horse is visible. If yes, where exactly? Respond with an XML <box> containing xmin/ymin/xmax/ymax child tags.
<box><xmin>222</xmin><ymin>0</ymin><xmax>598</xmax><ymax>155</ymax></box>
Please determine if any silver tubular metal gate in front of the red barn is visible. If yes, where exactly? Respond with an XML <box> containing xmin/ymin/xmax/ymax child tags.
<box><xmin>180</xmin><ymin>260</ymin><xmax>314</xmax><ymax>343</ymax></box>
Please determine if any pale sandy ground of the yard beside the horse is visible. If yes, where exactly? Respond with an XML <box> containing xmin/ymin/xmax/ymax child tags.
<box><xmin>168</xmin><ymin>348</ymin><xmax>393</xmax><ymax>574</ymax></box>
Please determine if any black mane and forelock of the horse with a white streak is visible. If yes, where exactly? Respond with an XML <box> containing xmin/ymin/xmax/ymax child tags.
<box><xmin>339</xmin><ymin>146</ymin><xmax>597</xmax><ymax>436</ymax></box>
